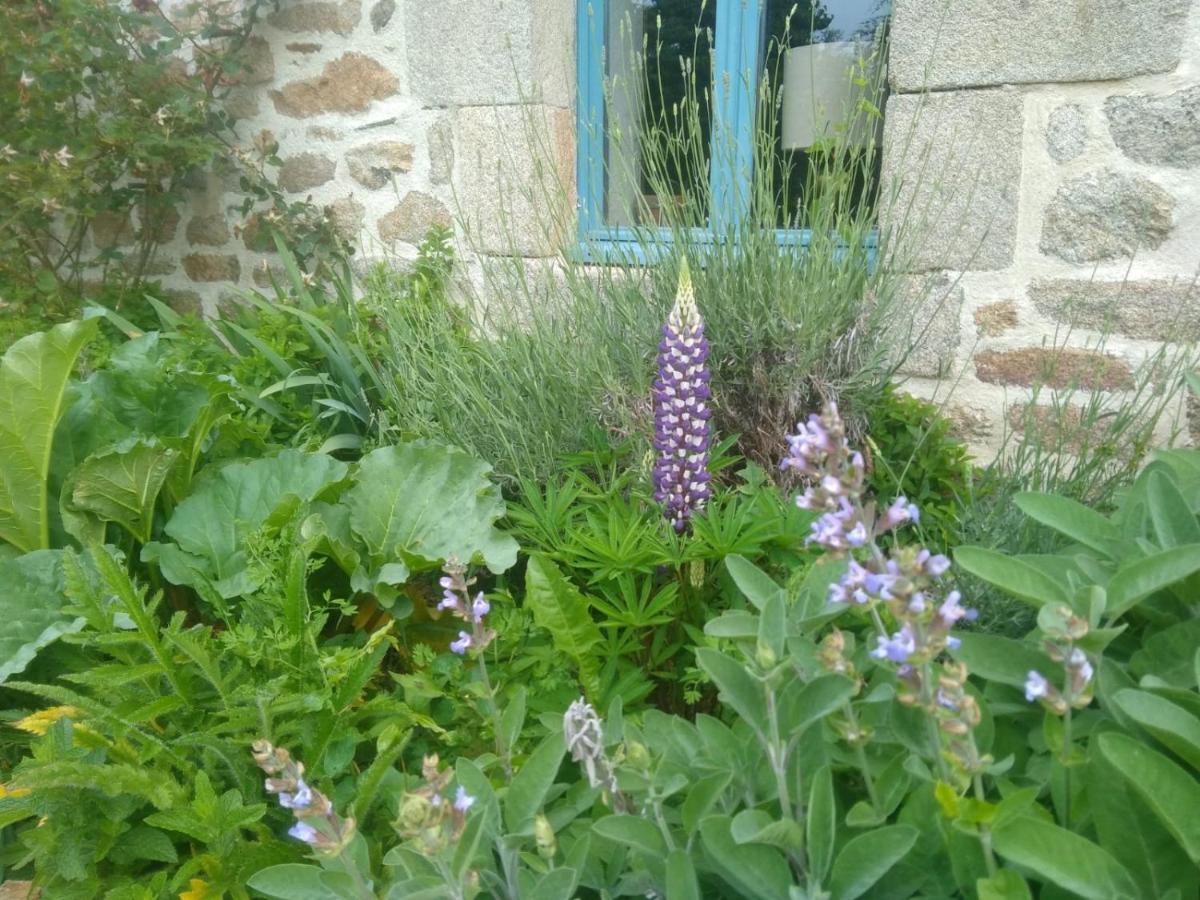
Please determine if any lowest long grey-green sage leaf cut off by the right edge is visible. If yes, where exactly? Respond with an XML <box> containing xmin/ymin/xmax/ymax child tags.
<box><xmin>1097</xmin><ymin>733</ymin><xmax>1200</xmax><ymax>864</ymax></box>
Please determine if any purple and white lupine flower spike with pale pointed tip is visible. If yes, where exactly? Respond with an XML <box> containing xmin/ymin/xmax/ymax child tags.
<box><xmin>654</xmin><ymin>259</ymin><xmax>712</xmax><ymax>533</ymax></box>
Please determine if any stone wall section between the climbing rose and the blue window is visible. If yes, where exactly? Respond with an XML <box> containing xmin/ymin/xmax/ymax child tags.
<box><xmin>152</xmin><ymin>0</ymin><xmax>575</xmax><ymax>311</ymax></box>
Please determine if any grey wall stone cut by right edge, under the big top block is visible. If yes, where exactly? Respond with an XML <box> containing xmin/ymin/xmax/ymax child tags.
<box><xmin>1104</xmin><ymin>85</ymin><xmax>1200</xmax><ymax>168</ymax></box>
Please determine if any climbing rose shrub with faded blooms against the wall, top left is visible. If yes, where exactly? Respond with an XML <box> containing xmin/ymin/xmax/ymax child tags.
<box><xmin>0</xmin><ymin>0</ymin><xmax>343</xmax><ymax>320</ymax></box>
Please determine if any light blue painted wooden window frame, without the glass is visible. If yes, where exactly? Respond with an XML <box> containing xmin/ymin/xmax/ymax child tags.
<box><xmin>576</xmin><ymin>0</ymin><xmax>876</xmax><ymax>264</ymax></box>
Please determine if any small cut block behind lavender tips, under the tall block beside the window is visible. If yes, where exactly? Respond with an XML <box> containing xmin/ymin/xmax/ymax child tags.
<box><xmin>893</xmin><ymin>275</ymin><xmax>962</xmax><ymax>378</ymax></box>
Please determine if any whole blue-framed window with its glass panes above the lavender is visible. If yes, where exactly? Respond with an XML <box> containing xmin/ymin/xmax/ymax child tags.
<box><xmin>577</xmin><ymin>0</ymin><xmax>888</xmax><ymax>262</ymax></box>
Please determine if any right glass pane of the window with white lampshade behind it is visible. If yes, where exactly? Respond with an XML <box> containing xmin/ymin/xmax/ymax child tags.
<box><xmin>752</xmin><ymin>0</ymin><xmax>890</xmax><ymax>228</ymax></box>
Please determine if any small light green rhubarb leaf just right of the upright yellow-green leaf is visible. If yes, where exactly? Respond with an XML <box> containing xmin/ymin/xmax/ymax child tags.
<box><xmin>68</xmin><ymin>437</ymin><xmax>179</xmax><ymax>544</ymax></box>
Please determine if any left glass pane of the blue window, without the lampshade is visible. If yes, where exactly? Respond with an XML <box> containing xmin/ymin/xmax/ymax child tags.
<box><xmin>602</xmin><ymin>0</ymin><xmax>715</xmax><ymax>226</ymax></box>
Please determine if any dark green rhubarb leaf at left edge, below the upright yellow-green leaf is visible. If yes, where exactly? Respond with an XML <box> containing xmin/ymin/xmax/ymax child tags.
<box><xmin>0</xmin><ymin>550</ymin><xmax>84</xmax><ymax>684</ymax></box>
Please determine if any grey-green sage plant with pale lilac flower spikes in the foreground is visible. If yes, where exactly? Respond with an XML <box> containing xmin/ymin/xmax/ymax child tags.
<box><xmin>234</xmin><ymin>415</ymin><xmax>1200</xmax><ymax>900</ymax></box>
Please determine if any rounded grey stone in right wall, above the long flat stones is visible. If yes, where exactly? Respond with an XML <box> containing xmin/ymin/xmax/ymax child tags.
<box><xmin>1039</xmin><ymin>169</ymin><xmax>1175</xmax><ymax>263</ymax></box>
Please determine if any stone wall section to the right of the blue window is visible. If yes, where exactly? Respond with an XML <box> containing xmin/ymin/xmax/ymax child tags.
<box><xmin>884</xmin><ymin>0</ymin><xmax>1200</xmax><ymax>456</ymax></box>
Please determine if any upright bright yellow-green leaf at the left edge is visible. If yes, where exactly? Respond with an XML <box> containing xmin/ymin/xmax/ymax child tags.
<box><xmin>0</xmin><ymin>319</ymin><xmax>97</xmax><ymax>551</ymax></box>
